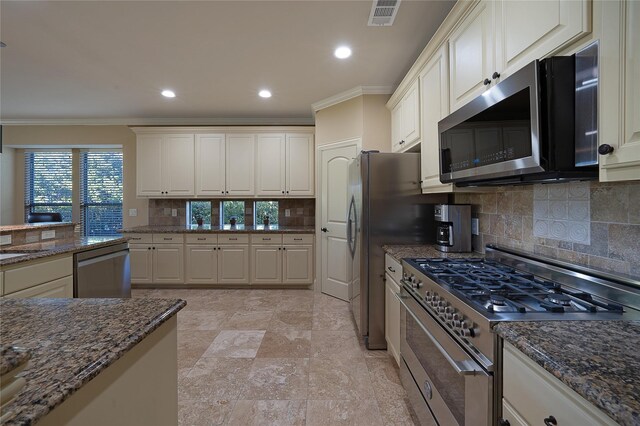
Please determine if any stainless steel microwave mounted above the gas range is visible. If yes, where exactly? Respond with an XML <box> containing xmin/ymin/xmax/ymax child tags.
<box><xmin>438</xmin><ymin>45</ymin><xmax>598</xmax><ymax>186</ymax></box>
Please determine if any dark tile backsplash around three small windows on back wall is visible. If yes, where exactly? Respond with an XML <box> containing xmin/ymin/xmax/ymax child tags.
<box><xmin>149</xmin><ymin>198</ymin><xmax>316</xmax><ymax>226</ymax></box>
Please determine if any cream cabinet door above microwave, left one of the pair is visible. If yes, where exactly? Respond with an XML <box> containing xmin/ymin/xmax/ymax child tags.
<box><xmin>449</xmin><ymin>0</ymin><xmax>496</xmax><ymax>112</ymax></box>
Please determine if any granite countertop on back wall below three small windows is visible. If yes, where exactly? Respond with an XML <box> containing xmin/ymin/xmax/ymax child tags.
<box><xmin>119</xmin><ymin>225</ymin><xmax>316</xmax><ymax>234</ymax></box>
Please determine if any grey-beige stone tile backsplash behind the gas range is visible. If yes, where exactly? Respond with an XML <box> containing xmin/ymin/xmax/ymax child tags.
<box><xmin>454</xmin><ymin>182</ymin><xmax>640</xmax><ymax>276</ymax></box>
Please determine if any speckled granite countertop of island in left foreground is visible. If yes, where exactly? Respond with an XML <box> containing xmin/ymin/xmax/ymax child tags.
<box><xmin>0</xmin><ymin>299</ymin><xmax>186</xmax><ymax>425</ymax></box>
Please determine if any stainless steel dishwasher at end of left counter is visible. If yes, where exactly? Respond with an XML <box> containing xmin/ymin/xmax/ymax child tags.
<box><xmin>73</xmin><ymin>243</ymin><xmax>131</xmax><ymax>297</ymax></box>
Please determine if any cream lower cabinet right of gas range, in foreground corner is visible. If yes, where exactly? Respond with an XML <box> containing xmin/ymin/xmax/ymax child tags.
<box><xmin>502</xmin><ymin>342</ymin><xmax>616</xmax><ymax>426</ymax></box>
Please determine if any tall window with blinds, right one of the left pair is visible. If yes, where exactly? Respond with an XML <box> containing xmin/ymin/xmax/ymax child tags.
<box><xmin>80</xmin><ymin>151</ymin><xmax>122</xmax><ymax>236</ymax></box>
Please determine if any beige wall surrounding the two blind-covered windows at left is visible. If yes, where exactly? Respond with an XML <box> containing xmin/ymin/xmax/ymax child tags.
<box><xmin>0</xmin><ymin>126</ymin><xmax>149</xmax><ymax>227</ymax></box>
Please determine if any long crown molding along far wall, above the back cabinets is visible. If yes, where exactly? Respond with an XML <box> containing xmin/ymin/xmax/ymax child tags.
<box><xmin>0</xmin><ymin>117</ymin><xmax>315</xmax><ymax>126</ymax></box>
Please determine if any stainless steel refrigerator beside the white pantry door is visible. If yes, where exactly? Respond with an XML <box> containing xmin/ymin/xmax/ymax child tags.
<box><xmin>347</xmin><ymin>151</ymin><xmax>447</xmax><ymax>349</ymax></box>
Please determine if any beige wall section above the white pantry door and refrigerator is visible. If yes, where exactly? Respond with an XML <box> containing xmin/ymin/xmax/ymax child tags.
<box><xmin>316</xmin><ymin>95</ymin><xmax>391</xmax><ymax>152</ymax></box>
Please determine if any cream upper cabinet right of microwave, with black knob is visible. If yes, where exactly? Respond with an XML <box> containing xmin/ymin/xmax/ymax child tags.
<box><xmin>598</xmin><ymin>1</ymin><xmax>640</xmax><ymax>182</ymax></box>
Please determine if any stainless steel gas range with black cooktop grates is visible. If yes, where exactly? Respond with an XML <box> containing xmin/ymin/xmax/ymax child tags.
<box><xmin>398</xmin><ymin>245</ymin><xmax>640</xmax><ymax>425</ymax></box>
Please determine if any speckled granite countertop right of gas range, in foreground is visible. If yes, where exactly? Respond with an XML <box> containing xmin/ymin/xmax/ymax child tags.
<box><xmin>494</xmin><ymin>321</ymin><xmax>640</xmax><ymax>425</ymax></box>
